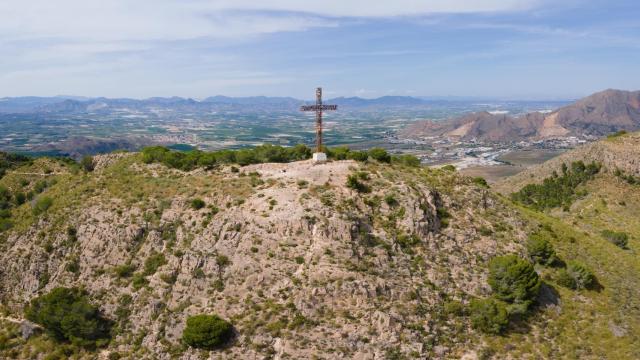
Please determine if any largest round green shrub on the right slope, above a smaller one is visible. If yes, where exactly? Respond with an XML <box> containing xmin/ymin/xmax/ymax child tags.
<box><xmin>489</xmin><ymin>255</ymin><xmax>541</xmax><ymax>304</ymax></box>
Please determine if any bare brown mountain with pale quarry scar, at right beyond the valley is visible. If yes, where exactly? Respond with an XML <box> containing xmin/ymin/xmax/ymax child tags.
<box><xmin>401</xmin><ymin>90</ymin><xmax>640</xmax><ymax>142</ymax></box>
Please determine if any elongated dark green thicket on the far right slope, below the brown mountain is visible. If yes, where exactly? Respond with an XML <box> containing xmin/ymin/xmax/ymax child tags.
<box><xmin>511</xmin><ymin>161</ymin><xmax>601</xmax><ymax>211</ymax></box>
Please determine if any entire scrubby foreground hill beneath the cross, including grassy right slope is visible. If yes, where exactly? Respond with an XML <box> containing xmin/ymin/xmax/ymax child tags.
<box><xmin>0</xmin><ymin>142</ymin><xmax>640</xmax><ymax>359</ymax></box>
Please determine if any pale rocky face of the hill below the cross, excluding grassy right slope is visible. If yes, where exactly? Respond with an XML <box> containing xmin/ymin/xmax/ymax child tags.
<box><xmin>0</xmin><ymin>154</ymin><xmax>527</xmax><ymax>359</ymax></box>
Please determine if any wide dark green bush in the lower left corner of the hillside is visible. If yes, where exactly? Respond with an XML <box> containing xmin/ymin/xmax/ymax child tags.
<box><xmin>25</xmin><ymin>287</ymin><xmax>111</xmax><ymax>347</ymax></box>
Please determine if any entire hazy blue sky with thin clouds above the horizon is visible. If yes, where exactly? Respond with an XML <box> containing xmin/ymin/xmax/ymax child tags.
<box><xmin>0</xmin><ymin>0</ymin><xmax>640</xmax><ymax>99</ymax></box>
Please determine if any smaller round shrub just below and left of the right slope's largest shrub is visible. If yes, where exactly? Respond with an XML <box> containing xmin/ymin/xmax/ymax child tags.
<box><xmin>469</xmin><ymin>298</ymin><xmax>509</xmax><ymax>335</ymax></box>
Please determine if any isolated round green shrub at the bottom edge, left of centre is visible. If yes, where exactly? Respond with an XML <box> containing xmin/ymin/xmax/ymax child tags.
<box><xmin>182</xmin><ymin>315</ymin><xmax>233</xmax><ymax>350</ymax></box>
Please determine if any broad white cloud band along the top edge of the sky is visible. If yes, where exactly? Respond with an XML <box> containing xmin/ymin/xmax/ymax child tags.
<box><xmin>0</xmin><ymin>0</ymin><xmax>541</xmax><ymax>41</ymax></box>
